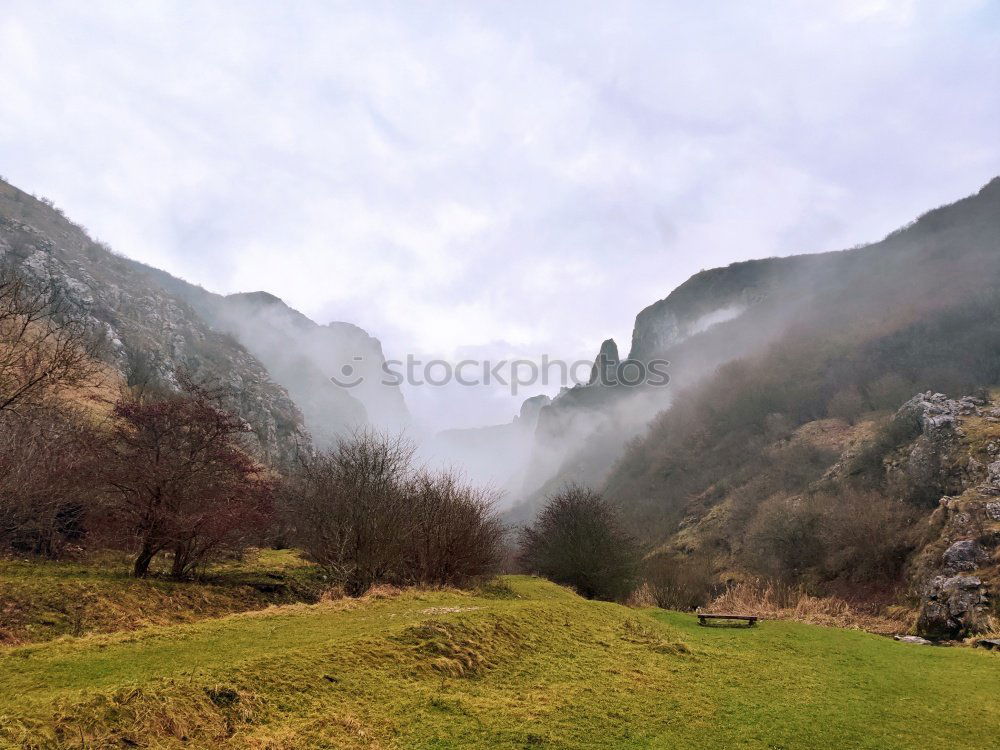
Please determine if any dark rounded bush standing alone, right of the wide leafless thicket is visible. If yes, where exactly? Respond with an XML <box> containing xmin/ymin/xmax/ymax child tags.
<box><xmin>521</xmin><ymin>485</ymin><xmax>641</xmax><ymax>601</ymax></box>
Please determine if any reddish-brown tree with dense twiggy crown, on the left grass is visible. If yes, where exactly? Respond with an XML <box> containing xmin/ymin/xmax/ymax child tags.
<box><xmin>103</xmin><ymin>384</ymin><xmax>271</xmax><ymax>578</ymax></box>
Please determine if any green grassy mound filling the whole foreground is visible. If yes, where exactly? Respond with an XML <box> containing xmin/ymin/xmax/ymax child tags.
<box><xmin>0</xmin><ymin>578</ymin><xmax>1000</xmax><ymax>748</ymax></box>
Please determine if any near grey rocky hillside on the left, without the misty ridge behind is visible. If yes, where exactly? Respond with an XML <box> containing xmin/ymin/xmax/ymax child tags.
<box><xmin>0</xmin><ymin>182</ymin><xmax>306</xmax><ymax>463</ymax></box>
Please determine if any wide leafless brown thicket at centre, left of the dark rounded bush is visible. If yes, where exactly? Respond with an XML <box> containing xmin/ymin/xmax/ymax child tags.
<box><xmin>283</xmin><ymin>431</ymin><xmax>505</xmax><ymax>596</ymax></box>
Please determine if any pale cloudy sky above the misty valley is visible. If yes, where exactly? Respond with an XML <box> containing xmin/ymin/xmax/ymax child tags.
<box><xmin>0</xmin><ymin>0</ymin><xmax>1000</xmax><ymax>429</ymax></box>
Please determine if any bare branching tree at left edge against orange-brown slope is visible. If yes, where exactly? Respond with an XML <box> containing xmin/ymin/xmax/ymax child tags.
<box><xmin>0</xmin><ymin>270</ymin><xmax>101</xmax><ymax>413</ymax></box>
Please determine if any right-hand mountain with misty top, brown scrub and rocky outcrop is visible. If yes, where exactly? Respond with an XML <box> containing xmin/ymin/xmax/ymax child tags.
<box><xmin>512</xmin><ymin>178</ymin><xmax>1000</xmax><ymax>638</ymax></box>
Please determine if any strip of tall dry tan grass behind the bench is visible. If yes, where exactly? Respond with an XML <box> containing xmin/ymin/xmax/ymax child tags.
<box><xmin>704</xmin><ymin>579</ymin><xmax>914</xmax><ymax>635</ymax></box>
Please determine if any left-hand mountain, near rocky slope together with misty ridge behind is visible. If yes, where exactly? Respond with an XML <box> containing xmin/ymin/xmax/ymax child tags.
<box><xmin>0</xmin><ymin>181</ymin><xmax>409</xmax><ymax>464</ymax></box>
